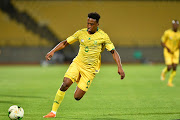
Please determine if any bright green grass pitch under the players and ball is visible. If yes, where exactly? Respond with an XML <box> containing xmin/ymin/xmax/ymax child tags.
<box><xmin>0</xmin><ymin>64</ymin><xmax>180</xmax><ymax>120</ymax></box>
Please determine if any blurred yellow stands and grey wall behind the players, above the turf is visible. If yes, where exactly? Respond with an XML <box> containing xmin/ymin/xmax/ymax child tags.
<box><xmin>0</xmin><ymin>0</ymin><xmax>180</xmax><ymax>64</ymax></box>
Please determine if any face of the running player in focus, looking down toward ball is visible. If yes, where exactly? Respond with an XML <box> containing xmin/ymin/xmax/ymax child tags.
<box><xmin>87</xmin><ymin>18</ymin><xmax>99</xmax><ymax>34</ymax></box>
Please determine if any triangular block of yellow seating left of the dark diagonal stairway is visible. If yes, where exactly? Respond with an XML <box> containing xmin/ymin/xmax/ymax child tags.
<box><xmin>0</xmin><ymin>11</ymin><xmax>52</xmax><ymax>46</ymax></box>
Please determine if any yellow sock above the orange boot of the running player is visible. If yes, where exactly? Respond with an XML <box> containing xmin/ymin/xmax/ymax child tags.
<box><xmin>52</xmin><ymin>89</ymin><xmax>65</xmax><ymax>112</ymax></box>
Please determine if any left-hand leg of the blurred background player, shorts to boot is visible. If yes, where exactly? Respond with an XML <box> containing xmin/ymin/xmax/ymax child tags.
<box><xmin>161</xmin><ymin>50</ymin><xmax>172</xmax><ymax>80</ymax></box>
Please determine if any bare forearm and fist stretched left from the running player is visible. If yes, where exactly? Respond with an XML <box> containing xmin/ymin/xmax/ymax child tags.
<box><xmin>45</xmin><ymin>40</ymin><xmax>69</xmax><ymax>60</ymax></box>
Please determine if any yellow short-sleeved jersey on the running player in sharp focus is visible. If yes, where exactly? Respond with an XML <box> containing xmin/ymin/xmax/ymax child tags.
<box><xmin>66</xmin><ymin>28</ymin><xmax>115</xmax><ymax>73</ymax></box>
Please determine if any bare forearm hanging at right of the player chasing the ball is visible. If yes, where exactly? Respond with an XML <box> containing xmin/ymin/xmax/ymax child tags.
<box><xmin>110</xmin><ymin>50</ymin><xmax>125</xmax><ymax>79</ymax></box>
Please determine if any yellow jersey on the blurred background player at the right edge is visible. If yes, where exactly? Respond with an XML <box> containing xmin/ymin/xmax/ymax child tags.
<box><xmin>161</xmin><ymin>29</ymin><xmax>180</xmax><ymax>52</ymax></box>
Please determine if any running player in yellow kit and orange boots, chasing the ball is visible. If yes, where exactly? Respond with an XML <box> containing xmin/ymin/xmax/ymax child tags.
<box><xmin>43</xmin><ymin>12</ymin><xmax>125</xmax><ymax>118</ymax></box>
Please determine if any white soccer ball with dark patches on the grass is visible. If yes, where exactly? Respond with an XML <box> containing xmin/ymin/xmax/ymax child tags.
<box><xmin>8</xmin><ymin>105</ymin><xmax>24</xmax><ymax>120</ymax></box>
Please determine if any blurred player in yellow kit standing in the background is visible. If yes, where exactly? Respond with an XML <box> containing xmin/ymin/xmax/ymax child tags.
<box><xmin>161</xmin><ymin>20</ymin><xmax>180</xmax><ymax>87</ymax></box>
